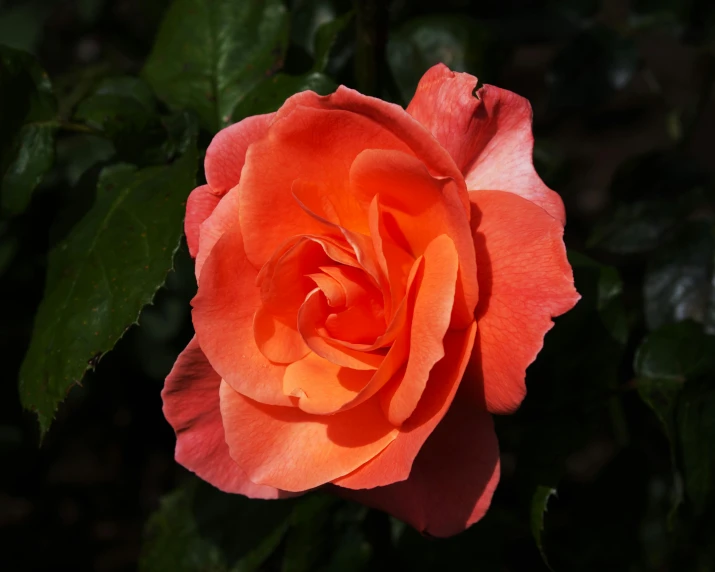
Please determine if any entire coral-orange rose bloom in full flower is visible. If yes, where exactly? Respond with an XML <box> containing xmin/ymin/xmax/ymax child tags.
<box><xmin>162</xmin><ymin>65</ymin><xmax>579</xmax><ymax>536</ymax></box>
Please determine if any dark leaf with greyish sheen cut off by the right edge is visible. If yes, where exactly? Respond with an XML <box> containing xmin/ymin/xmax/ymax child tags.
<box><xmin>643</xmin><ymin>221</ymin><xmax>715</xmax><ymax>329</ymax></box>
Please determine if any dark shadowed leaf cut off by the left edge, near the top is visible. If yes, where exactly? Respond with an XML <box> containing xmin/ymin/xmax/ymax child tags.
<box><xmin>0</xmin><ymin>46</ymin><xmax>56</xmax><ymax>215</ymax></box>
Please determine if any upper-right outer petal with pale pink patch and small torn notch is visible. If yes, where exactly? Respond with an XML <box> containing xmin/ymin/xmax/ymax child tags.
<box><xmin>407</xmin><ymin>64</ymin><xmax>566</xmax><ymax>224</ymax></box>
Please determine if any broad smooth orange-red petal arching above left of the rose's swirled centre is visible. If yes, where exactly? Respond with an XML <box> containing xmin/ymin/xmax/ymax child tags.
<box><xmin>240</xmin><ymin>107</ymin><xmax>412</xmax><ymax>268</ymax></box>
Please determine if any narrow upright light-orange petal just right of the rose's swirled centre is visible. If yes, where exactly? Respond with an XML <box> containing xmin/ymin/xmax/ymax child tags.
<box><xmin>380</xmin><ymin>234</ymin><xmax>459</xmax><ymax>426</ymax></box>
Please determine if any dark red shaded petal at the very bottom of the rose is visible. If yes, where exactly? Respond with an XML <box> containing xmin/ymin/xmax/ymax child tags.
<box><xmin>338</xmin><ymin>388</ymin><xmax>499</xmax><ymax>537</ymax></box>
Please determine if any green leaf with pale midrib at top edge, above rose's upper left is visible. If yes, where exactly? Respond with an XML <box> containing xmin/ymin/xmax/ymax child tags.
<box><xmin>142</xmin><ymin>0</ymin><xmax>288</xmax><ymax>132</ymax></box>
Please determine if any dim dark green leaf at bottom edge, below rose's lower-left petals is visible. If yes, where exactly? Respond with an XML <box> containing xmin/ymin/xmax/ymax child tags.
<box><xmin>139</xmin><ymin>478</ymin><xmax>295</xmax><ymax>572</ymax></box>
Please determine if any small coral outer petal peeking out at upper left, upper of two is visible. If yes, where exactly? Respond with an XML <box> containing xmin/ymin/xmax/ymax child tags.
<box><xmin>204</xmin><ymin>113</ymin><xmax>275</xmax><ymax>196</ymax></box>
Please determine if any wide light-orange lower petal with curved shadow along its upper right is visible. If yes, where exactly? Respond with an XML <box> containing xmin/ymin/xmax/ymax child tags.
<box><xmin>220</xmin><ymin>382</ymin><xmax>397</xmax><ymax>491</ymax></box>
